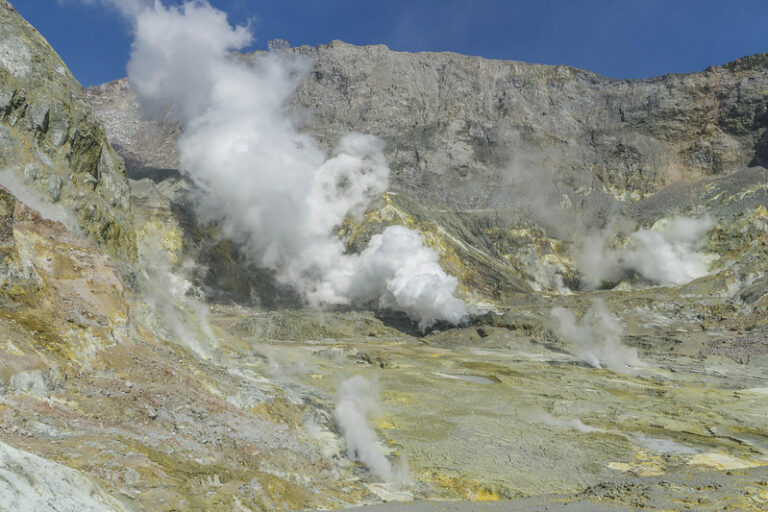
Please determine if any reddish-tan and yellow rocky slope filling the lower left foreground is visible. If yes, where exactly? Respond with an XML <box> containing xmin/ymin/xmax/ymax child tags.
<box><xmin>0</xmin><ymin>188</ymin><xmax>382</xmax><ymax>512</ymax></box>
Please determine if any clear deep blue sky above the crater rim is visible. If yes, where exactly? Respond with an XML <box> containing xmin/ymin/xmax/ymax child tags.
<box><xmin>10</xmin><ymin>0</ymin><xmax>768</xmax><ymax>86</ymax></box>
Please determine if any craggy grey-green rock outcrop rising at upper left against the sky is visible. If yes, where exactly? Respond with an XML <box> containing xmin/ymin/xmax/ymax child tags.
<box><xmin>0</xmin><ymin>0</ymin><xmax>136</xmax><ymax>270</ymax></box>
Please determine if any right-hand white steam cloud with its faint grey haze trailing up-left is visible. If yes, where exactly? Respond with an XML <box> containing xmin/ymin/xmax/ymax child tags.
<box><xmin>500</xmin><ymin>149</ymin><xmax>714</xmax><ymax>289</ymax></box>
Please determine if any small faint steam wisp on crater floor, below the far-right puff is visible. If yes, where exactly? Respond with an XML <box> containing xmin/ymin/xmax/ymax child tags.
<box><xmin>550</xmin><ymin>299</ymin><xmax>642</xmax><ymax>373</ymax></box>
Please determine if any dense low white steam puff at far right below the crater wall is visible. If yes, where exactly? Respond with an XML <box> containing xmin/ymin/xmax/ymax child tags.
<box><xmin>576</xmin><ymin>217</ymin><xmax>715</xmax><ymax>288</ymax></box>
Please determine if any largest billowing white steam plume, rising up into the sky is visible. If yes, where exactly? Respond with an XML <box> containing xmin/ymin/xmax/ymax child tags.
<box><xmin>123</xmin><ymin>2</ymin><xmax>467</xmax><ymax>329</ymax></box>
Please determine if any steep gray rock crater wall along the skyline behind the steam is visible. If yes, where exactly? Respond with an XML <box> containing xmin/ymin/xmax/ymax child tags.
<box><xmin>87</xmin><ymin>41</ymin><xmax>768</xmax><ymax>209</ymax></box>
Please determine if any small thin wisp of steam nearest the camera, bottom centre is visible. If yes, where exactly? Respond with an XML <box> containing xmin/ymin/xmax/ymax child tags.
<box><xmin>333</xmin><ymin>375</ymin><xmax>408</xmax><ymax>481</ymax></box>
